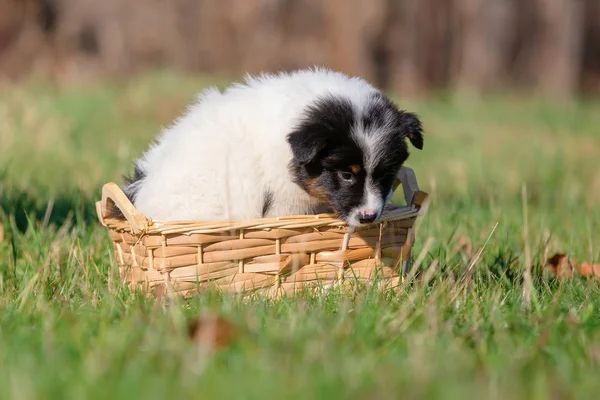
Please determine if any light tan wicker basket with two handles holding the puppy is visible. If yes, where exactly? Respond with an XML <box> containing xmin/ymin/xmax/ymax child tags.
<box><xmin>96</xmin><ymin>167</ymin><xmax>427</xmax><ymax>296</ymax></box>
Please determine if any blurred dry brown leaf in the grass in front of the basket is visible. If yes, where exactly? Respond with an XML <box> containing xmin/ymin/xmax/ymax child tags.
<box><xmin>188</xmin><ymin>314</ymin><xmax>240</xmax><ymax>350</ymax></box>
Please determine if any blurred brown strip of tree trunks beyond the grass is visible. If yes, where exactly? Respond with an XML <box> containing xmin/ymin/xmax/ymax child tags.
<box><xmin>0</xmin><ymin>0</ymin><xmax>600</xmax><ymax>98</ymax></box>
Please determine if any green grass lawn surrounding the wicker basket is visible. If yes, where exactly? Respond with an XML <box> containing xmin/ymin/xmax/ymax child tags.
<box><xmin>0</xmin><ymin>73</ymin><xmax>600</xmax><ymax>399</ymax></box>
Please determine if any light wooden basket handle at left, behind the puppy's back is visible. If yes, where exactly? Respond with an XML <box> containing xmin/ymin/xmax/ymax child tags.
<box><xmin>96</xmin><ymin>182</ymin><xmax>150</xmax><ymax>234</ymax></box>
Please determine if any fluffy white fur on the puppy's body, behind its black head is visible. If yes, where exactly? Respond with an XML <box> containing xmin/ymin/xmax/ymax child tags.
<box><xmin>128</xmin><ymin>69</ymin><xmax>379</xmax><ymax>220</ymax></box>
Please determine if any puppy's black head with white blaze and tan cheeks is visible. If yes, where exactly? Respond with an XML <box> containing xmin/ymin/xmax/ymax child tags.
<box><xmin>287</xmin><ymin>92</ymin><xmax>423</xmax><ymax>226</ymax></box>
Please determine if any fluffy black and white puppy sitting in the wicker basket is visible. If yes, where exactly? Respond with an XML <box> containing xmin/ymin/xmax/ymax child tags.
<box><xmin>124</xmin><ymin>69</ymin><xmax>423</xmax><ymax>226</ymax></box>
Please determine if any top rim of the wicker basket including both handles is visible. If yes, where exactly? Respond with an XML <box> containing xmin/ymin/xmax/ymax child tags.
<box><xmin>96</xmin><ymin>167</ymin><xmax>428</xmax><ymax>235</ymax></box>
